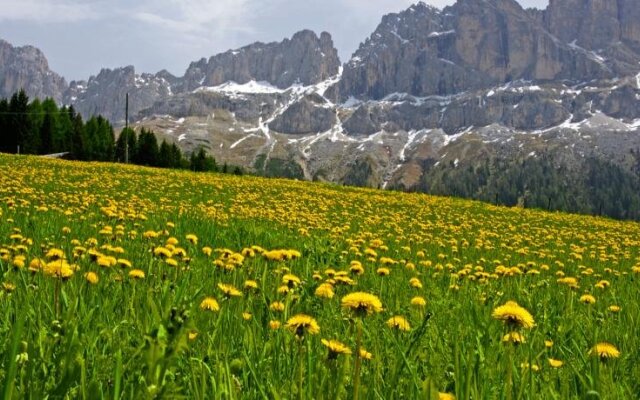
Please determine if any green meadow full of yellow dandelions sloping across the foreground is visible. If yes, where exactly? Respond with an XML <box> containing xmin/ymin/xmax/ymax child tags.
<box><xmin>0</xmin><ymin>155</ymin><xmax>640</xmax><ymax>399</ymax></box>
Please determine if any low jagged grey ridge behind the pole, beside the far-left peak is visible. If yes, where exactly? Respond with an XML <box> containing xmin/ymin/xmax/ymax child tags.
<box><xmin>64</xmin><ymin>66</ymin><xmax>172</xmax><ymax>125</ymax></box>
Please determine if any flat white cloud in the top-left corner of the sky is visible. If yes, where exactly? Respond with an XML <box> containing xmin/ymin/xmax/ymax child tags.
<box><xmin>0</xmin><ymin>0</ymin><xmax>99</xmax><ymax>23</ymax></box>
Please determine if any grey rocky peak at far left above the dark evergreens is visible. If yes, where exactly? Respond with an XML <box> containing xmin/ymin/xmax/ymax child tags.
<box><xmin>0</xmin><ymin>39</ymin><xmax>67</xmax><ymax>101</ymax></box>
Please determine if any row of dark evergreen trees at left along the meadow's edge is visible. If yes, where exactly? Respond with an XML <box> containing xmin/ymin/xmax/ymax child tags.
<box><xmin>0</xmin><ymin>90</ymin><xmax>243</xmax><ymax>174</ymax></box>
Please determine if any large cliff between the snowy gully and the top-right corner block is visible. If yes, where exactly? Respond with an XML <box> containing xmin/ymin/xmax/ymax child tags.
<box><xmin>339</xmin><ymin>0</ymin><xmax>628</xmax><ymax>100</ymax></box>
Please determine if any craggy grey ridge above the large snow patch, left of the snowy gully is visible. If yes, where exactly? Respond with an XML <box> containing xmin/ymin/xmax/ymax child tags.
<box><xmin>182</xmin><ymin>30</ymin><xmax>340</xmax><ymax>91</ymax></box>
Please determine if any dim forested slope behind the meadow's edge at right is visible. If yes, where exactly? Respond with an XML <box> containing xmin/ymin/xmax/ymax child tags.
<box><xmin>417</xmin><ymin>154</ymin><xmax>640</xmax><ymax>220</ymax></box>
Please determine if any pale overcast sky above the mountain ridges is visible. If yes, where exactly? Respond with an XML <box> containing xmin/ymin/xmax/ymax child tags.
<box><xmin>0</xmin><ymin>0</ymin><xmax>548</xmax><ymax>80</ymax></box>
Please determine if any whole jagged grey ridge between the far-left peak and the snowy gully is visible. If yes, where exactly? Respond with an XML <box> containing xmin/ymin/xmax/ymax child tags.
<box><xmin>64</xmin><ymin>31</ymin><xmax>340</xmax><ymax>122</ymax></box>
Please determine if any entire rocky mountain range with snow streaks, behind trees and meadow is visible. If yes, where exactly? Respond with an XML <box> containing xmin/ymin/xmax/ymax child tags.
<box><xmin>0</xmin><ymin>0</ymin><xmax>640</xmax><ymax>206</ymax></box>
